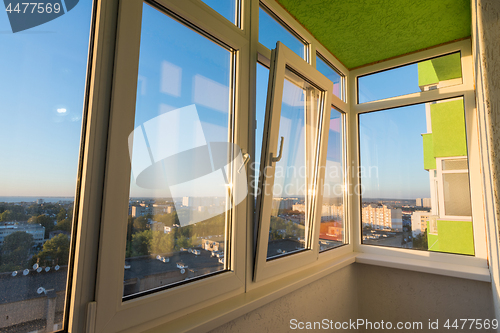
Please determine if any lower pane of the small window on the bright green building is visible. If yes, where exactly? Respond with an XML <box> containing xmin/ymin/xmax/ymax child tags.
<box><xmin>443</xmin><ymin>173</ymin><xmax>472</xmax><ymax>216</ymax></box>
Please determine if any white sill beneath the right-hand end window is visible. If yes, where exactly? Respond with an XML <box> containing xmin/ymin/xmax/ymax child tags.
<box><xmin>356</xmin><ymin>253</ymin><xmax>491</xmax><ymax>282</ymax></box>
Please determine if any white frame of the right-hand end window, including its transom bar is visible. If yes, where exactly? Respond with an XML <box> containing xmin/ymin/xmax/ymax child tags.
<box><xmin>349</xmin><ymin>39</ymin><xmax>489</xmax><ymax>272</ymax></box>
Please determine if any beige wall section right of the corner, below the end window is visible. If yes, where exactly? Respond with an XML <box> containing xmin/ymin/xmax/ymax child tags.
<box><xmin>356</xmin><ymin>264</ymin><xmax>495</xmax><ymax>333</ymax></box>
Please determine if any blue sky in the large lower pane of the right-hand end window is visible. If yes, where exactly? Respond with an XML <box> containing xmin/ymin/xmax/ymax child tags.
<box><xmin>359</xmin><ymin>104</ymin><xmax>430</xmax><ymax>199</ymax></box>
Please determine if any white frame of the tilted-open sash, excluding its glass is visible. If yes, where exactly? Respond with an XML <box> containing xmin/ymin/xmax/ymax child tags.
<box><xmin>254</xmin><ymin>42</ymin><xmax>333</xmax><ymax>281</ymax></box>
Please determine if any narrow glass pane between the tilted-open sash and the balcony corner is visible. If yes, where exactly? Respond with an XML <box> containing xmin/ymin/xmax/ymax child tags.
<box><xmin>319</xmin><ymin>108</ymin><xmax>344</xmax><ymax>251</ymax></box>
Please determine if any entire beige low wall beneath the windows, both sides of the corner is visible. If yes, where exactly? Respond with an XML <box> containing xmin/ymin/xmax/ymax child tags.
<box><xmin>211</xmin><ymin>264</ymin><xmax>494</xmax><ymax>333</ymax></box>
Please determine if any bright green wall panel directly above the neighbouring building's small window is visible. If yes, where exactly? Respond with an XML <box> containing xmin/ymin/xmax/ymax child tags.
<box><xmin>431</xmin><ymin>99</ymin><xmax>467</xmax><ymax>157</ymax></box>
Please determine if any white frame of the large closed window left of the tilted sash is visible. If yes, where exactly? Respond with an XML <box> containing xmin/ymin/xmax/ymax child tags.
<box><xmin>89</xmin><ymin>0</ymin><xmax>249</xmax><ymax>332</ymax></box>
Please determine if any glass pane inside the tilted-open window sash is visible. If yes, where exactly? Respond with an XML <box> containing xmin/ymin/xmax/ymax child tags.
<box><xmin>267</xmin><ymin>69</ymin><xmax>321</xmax><ymax>259</ymax></box>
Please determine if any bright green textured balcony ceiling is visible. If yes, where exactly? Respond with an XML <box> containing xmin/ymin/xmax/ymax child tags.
<box><xmin>277</xmin><ymin>0</ymin><xmax>471</xmax><ymax>68</ymax></box>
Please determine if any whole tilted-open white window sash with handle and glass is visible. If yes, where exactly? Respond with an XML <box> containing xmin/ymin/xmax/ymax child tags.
<box><xmin>254</xmin><ymin>42</ymin><xmax>333</xmax><ymax>281</ymax></box>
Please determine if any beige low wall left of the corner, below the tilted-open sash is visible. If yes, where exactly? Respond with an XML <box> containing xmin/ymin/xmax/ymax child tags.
<box><xmin>208</xmin><ymin>265</ymin><xmax>358</xmax><ymax>333</ymax></box>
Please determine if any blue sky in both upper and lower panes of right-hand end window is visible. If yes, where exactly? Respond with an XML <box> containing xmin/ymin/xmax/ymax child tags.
<box><xmin>358</xmin><ymin>64</ymin><xmax>430</xmax><ymax>199</ymax></box>
